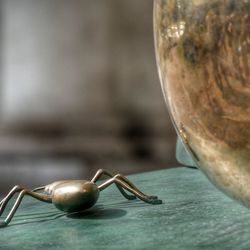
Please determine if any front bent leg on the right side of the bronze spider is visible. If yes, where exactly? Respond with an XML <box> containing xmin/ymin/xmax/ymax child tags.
<box><xmin>98</xmin><ymin>175</ymin><xmax>162</xmax><ymax>204</ymax></box>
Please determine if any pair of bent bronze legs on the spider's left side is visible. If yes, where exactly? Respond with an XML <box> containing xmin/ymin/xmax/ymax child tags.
<box><xmin>0</xmin><ymin>186</ymin><xmax>51</xmax><ymax>228</ymax></box>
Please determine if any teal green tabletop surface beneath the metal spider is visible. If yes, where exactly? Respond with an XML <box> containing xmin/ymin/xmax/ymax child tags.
<box><xmin>0</xmin><ymin>167</ymin><xmax>250</xmax><ymax>250</ymax></box>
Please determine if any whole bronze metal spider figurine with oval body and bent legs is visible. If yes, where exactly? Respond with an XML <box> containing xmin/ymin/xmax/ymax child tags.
<box><xmin>0</xmin><ymin>169</ymin><xmax>162</xmax><ymax>227</ymax></box>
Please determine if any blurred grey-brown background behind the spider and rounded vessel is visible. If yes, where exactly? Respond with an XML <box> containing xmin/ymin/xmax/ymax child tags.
<box><xmin>0</xmin><ymin>0</ymin><xmax>177</xmax><ymax>191</ymax></box>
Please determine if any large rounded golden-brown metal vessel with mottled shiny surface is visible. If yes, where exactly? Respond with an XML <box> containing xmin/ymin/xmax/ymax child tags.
<box><xmin>154</xmin><ymin>0</ymin><xmax>250</xmax><ymax>207</ymax></box>
